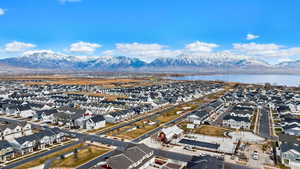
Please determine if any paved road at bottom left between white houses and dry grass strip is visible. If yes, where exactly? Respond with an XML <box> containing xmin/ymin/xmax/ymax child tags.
<box><xmin>2</xmin><ymin>141</ymin><xmax>80</xmax><ymax>169</ymax></box>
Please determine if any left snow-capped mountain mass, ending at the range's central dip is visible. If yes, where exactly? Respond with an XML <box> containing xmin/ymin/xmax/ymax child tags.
<box><xmin>0</xmin><ymin>50</ymin><xmax>145</xmax><ymax>70</ymax></box>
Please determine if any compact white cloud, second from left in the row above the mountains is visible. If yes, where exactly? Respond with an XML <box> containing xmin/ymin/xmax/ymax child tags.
<box><xmin>68</xmin><ymin>42</ymin><xmax>102</xmax><ymax>54</ymax></box>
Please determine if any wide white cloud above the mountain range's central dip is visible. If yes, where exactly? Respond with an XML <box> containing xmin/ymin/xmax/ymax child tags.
<box><xmin>108</xmin><ymin>42</ymin><xmax>182</xmax><ymax>61</ymax></box>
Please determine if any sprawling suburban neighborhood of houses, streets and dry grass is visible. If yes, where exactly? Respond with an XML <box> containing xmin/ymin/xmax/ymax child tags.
<box><xmin>0</xmin><ymin>76</ymin><xmax>300</xmax><ymax>169</ymax></box>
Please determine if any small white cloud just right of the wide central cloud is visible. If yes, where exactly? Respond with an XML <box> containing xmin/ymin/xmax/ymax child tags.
<box><xmin>185</xmin><ymin>41</ymin><xmax>219</xmax><ymax>53</ymax></box>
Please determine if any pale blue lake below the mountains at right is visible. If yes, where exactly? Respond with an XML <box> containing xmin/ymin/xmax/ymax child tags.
<box><xmin>168</xmin><ymin>74</ymin><xmax>300</xmax><ymax>86</ymax></box>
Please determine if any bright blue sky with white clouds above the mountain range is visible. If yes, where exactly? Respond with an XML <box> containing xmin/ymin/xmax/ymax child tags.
<box><xmin>0</xmin><ymin>0</ymin><xmax>300</xmax><ymax>63</ymax></box>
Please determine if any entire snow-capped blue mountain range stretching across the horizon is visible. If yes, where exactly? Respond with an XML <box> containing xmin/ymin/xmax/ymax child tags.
<box><xmin>0</xmin><ymin>51</ymin><xmax>300</xmax><ymax>73</ymax></box>
